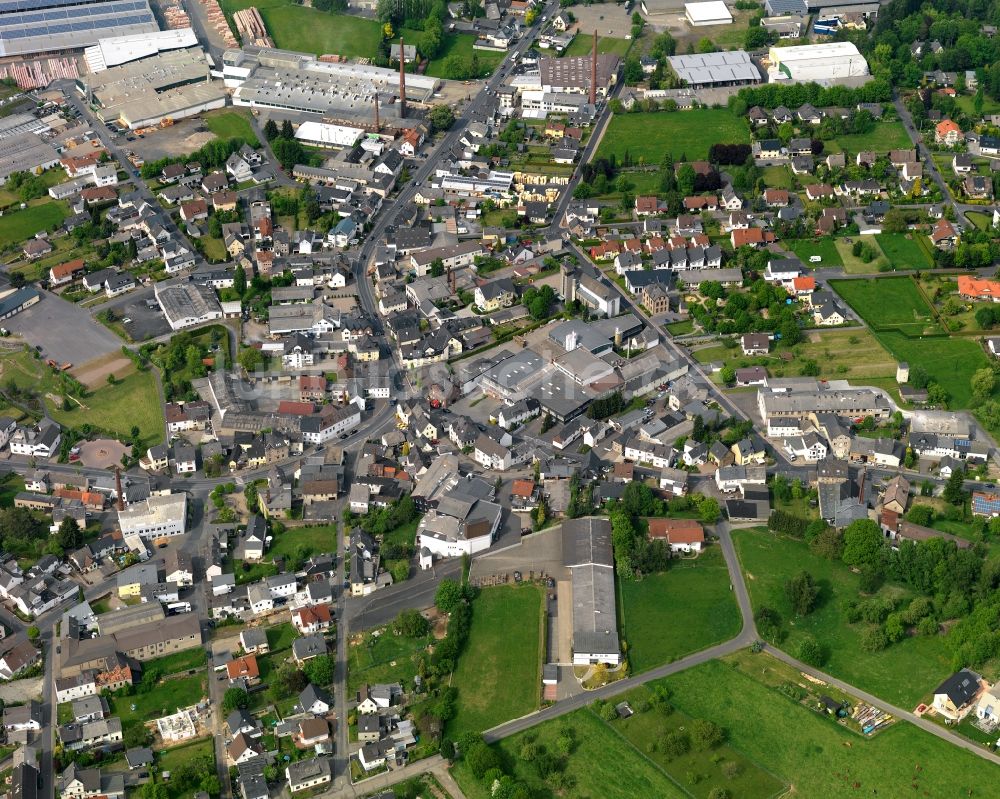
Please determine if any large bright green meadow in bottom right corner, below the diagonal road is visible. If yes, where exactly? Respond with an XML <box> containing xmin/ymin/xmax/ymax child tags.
<box><xmin>660</xmin><ymin>655</ymin><xmax>996</xmax><ymax>799</ymax></box>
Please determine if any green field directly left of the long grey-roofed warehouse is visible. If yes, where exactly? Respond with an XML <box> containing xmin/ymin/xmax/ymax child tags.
<box><xmin>448</xmin><ymin>585</ymin><xmax>543</xmax><ymax>738</ymax></box>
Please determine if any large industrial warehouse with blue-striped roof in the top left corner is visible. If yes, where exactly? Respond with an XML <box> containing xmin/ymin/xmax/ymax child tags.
<box><xmin>0</xmin><ymin>0</ymin><xmax>159</xmax><ymax>57</ymax></box>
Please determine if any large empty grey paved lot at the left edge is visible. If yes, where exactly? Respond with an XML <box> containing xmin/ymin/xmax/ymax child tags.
<box><xmin>4</xmin><ymin>291</ymin><xmax>122</xmax><ymax>366</ymax></box>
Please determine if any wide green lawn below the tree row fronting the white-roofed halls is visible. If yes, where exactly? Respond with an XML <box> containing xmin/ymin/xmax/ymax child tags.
<box><xmin>597</xmin><ymin>108</ymin><xmax>750</xmax><ymax>164</ymax></box>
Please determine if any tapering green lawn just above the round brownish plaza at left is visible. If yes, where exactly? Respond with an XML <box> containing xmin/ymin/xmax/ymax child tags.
<box><xmin>49</xmin><ymin>370</ymin><xmax>163</xmax><ymax>446</ymax></box>
